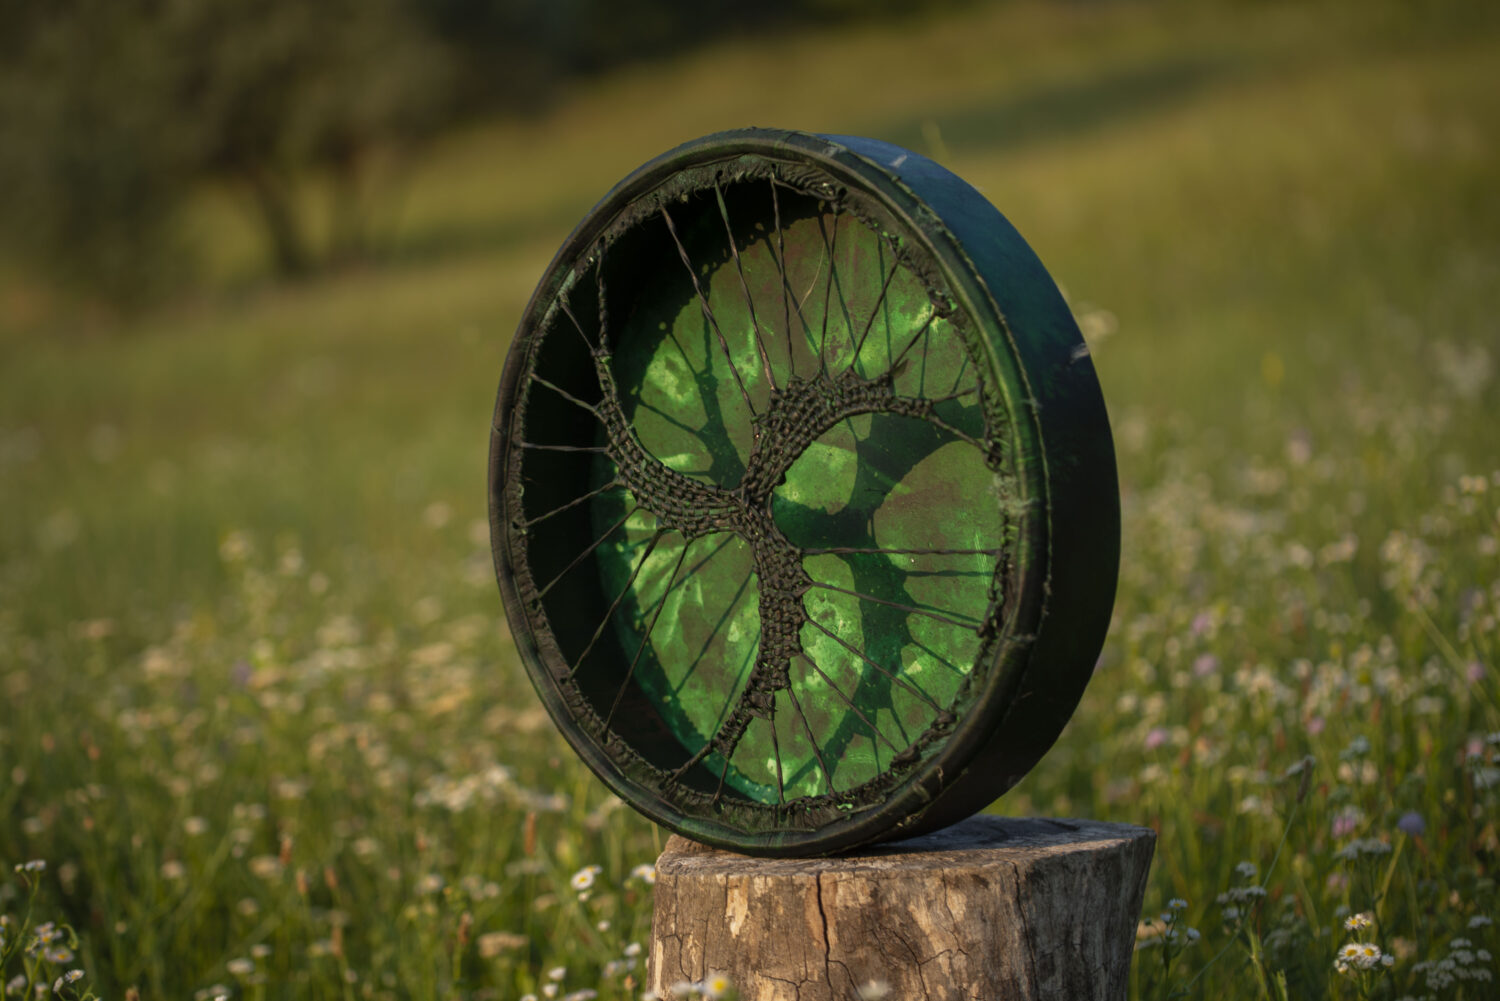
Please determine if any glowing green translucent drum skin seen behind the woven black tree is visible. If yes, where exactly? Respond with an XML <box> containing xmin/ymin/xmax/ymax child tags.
<box><xmin>591</xmin><ymin>211</ymin><xmax>1005</xmax><ymax>804</ymax></box>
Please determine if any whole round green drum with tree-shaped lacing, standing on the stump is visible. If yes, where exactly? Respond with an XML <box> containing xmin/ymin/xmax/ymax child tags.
<box><xmin>489</xmin><ymin>129</ymin><xmax>1119</xmax><ymax>855</ymax></box>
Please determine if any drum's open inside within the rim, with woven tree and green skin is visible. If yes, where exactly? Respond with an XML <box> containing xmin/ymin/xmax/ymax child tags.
<box><xmin>516</xmin><ymin>170</ymin><xmax>1011</xmax><ymax>824</ymax></box>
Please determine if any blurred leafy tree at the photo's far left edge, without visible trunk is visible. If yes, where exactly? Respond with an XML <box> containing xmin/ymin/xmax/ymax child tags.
<box><xmin>0</xmin><ymin>0</ymin><xmax>188</xmax><ymax>300</ymax></box>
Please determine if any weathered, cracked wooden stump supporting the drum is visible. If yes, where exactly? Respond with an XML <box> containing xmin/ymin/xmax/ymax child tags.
<box><xmin>650</xmin><ymin>816</ymin><xmax>1157</xmax><ymax>1001</ymax></box>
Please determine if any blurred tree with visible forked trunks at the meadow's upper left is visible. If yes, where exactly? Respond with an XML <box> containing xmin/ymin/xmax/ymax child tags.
<box><xmin>167</xmin><ymin>0</ymin><xmax>447</xmax><ymax>275</ymax></box>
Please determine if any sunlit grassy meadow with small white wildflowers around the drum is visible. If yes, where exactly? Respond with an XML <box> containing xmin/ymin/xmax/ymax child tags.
<box><xmin>0</xmin><ymin>3</ymin><xmax>1500</xmax><ymax>1001</ymax></box>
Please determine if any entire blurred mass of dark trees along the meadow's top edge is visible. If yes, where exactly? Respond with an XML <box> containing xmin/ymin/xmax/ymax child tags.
<box><xmin>0</xmin><ymin>0</ymin><xmax>978</xmax><ymax>303</ymax></box>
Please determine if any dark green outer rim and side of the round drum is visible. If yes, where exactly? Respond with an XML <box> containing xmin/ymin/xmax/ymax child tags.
<box><xmin>489</xmin><ymin>129</ymin><xmax>1119</xmax><ymax>855</ymax></box>
